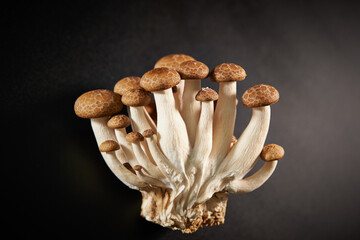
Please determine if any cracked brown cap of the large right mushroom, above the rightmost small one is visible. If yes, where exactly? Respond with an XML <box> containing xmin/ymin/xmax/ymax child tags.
<box><xmin>241</xmin><ymin>84</ymin><xmax>280</xmax><ymax>108</ymax></box>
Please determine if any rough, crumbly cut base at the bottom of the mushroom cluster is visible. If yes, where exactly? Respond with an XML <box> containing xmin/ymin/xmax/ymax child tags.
<box><xmin>141</xmin><ymin>188</ymin><xmax>228</xmax><ymax>233</ymax></box>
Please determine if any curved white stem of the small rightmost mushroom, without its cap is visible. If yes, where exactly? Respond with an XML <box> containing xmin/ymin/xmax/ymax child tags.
<box><xmin>226</xmin><ymin>160</ymin><xmax>278</xmax><ymax>193</ymax></box>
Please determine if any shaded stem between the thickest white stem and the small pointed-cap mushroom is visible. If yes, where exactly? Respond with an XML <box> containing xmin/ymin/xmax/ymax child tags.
<box><xmin>181</xmin><ymin>79</ymin><xmax>201</xmax><ymax>147</ymax></box>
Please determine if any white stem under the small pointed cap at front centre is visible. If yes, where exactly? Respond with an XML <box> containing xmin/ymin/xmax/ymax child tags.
<box><xmin>187</xmin><ymin>101</ymin><xmax>214</xmax><ymax>206</ymax></box>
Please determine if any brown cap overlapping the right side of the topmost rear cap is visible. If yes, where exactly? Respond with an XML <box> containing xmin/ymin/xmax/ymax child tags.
<box><xmin>177</xmin><ymin>60</ymin><xmax>209</xmax><ymax>79</ymax></box>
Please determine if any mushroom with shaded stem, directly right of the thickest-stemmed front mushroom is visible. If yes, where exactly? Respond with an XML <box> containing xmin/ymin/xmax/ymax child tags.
<box><xmin>178</xmin><ymin>60</ymin><xmax>209</xmax><ymax>147</ymax></box>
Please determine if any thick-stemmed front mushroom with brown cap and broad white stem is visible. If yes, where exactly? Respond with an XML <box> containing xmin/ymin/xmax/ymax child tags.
<box><xmin>140</xmin><ymin>68</ymin><xmax>190</xmax><ymax>172</ymax></box>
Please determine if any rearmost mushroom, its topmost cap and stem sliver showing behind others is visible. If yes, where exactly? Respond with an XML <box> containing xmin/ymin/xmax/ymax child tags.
<box><xmin>154</xmin><ymin>54</ymin><xmax>195</xmax><ymax>111</ymax></box>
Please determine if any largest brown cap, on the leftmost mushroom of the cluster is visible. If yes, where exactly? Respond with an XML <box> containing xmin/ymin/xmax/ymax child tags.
<box><xmin>74</xmin><ymin>89</ymin><xmax>123</xmax><ymax>118</ymax></box>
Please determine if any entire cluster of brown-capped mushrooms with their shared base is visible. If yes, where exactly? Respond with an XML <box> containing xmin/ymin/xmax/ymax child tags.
<box><xmin>74</xmin><ymin>54</ymin><xmax>284</xmax><ymax>233</ymax></box>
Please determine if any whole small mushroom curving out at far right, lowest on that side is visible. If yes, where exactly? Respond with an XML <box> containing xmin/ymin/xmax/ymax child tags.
<box><xmin>226</xmin><ymin>144</ymin><xmax>285</xmax><ymax>193</ymax></box>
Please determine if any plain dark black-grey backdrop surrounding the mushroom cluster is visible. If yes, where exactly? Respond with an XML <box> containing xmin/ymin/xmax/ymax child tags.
<box><xmin>1</xmin><ymin>1</ymin><xmax>360</xmax><ymax>239</ymax></box>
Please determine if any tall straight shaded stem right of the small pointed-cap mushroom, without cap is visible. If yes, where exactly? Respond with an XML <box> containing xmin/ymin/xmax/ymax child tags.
<box><xmin>209</xmin><ymin>81</ymin><xmax>236</xmax><ymax>174</ymax></box>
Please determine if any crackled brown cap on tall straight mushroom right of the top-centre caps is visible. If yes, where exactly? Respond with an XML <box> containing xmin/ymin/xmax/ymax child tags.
<box><xmin>210</xmin><ymin>63</ymin><xmax>246</xmax><ymax>82</ymax></box>
